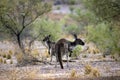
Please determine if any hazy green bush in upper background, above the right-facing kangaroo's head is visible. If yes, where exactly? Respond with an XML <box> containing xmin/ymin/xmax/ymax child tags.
<box><xmin>70</xmin><ymin>8</ymin><xmax>98</xmax><ymax>27</ymax></box>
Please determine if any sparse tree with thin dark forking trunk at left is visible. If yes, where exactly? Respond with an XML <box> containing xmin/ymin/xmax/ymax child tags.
<box><xmin>0</xmin><ymin>0</ymin><xmax>51</xmax><ymax>65</ymax></box>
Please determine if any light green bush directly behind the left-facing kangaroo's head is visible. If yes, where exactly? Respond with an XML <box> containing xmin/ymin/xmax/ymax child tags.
<box><xmin>31</xmin><ymin>18</ymin><xmax>63</xmax><ymax>41</ymax></box>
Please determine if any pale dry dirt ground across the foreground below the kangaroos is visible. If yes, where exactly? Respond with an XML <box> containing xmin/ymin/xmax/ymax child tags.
<box><xmin>0</xmin><ymin>57</ymin><xmax>120</xmax><ymax>80</ymax></box>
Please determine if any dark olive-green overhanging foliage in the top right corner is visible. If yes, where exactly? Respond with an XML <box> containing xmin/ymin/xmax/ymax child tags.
<box><xmin>83</xmin><ymin>0</ymin><xmax>120</xmax><ymax>21</ymax></box>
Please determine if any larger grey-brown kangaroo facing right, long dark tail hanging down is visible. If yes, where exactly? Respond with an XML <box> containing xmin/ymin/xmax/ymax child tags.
<box><xmin>55</xmin><ymin>34</ymin><xmax>85</xmax><ymax>69</ymax></box>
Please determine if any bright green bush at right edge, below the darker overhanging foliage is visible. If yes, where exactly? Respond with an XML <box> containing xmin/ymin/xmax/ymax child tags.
<box><xmin>87</xmin><ymin>23</ymin><xmax>120</xmax><ymax>53</ymax></box>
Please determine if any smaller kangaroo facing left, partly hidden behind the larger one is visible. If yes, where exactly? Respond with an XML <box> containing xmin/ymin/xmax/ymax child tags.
<box><xmin>43</xmin><ymin>35</ymin><xmax>55</xmax><ymax>61</ymax></box>
